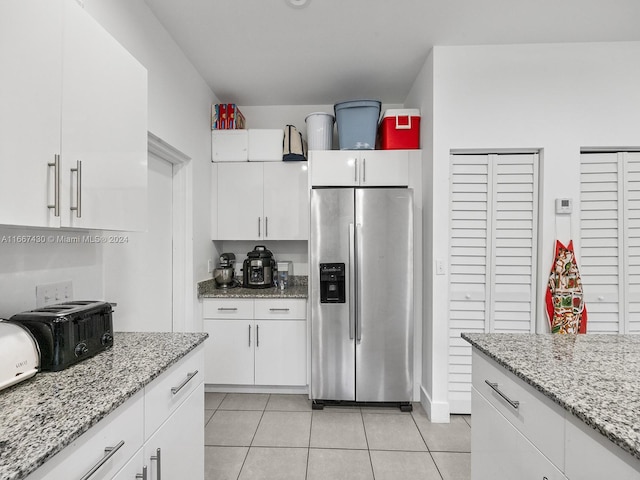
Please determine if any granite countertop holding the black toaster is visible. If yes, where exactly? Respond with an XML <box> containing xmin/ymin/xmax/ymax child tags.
<box><xmin>0</xmin><ymin>332</ymin><xmax>208</xmax><ymax>480</ymax></box>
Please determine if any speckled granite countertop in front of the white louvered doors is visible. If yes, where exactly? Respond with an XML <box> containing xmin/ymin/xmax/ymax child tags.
<box><xmin>462</xmin><ymin>333</ymin><xmax>640</xmax><ymax>459</ymax></box>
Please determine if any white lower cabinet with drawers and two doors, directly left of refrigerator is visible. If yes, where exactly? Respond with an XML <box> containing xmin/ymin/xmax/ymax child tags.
<box><xmin>203</xmin><ymin>299</ymin><xmax>307</xmax><ymax>386</ymax></box>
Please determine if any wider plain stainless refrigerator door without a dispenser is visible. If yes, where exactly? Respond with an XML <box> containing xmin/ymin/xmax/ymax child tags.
<box><xmin>355</xmin><ymin>188</ymin><xmax>413</xmax><ymax>402</ymax></box>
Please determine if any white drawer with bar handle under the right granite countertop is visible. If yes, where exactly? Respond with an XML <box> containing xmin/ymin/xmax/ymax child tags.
<box><xmin>472</xmin><ymin>349</ymin><xmax>565</xmax><ymax>469</ymax></box>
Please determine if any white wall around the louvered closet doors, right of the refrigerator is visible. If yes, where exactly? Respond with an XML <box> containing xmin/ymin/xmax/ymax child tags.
<box><xmin>414</xmin><ymin>42</ymin><xmax>640</xmax><ymax>420</ymax></box>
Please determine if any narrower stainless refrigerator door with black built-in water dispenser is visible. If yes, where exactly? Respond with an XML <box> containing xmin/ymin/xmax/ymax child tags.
<box><xmin>309</xmin><ymin>188</ymin><xmax>356</xmax><ymax>401</ymax></box>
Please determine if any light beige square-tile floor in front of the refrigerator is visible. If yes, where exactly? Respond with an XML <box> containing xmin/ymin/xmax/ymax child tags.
<box><xmin>204</xmin><ymin>393</ymin><xmax>471</xmax><ymax>480</ymax></box>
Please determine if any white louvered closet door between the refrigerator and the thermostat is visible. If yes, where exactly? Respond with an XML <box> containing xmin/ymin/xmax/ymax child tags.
<box><xmin>449</xmin><ymin>154</ymin><xmax>538</xmax><ymax>413</ymax></box>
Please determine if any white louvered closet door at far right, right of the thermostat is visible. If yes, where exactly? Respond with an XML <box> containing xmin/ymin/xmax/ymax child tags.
<box><xmin>580</xmin><ymin>152</ymin><xmax>640</xmax><ymax>333</ymax></box>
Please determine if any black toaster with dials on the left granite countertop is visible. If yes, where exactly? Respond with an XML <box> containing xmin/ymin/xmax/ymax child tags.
<box><xmin>9</xmin><ymin>301</ymin><xmax>113</xmax><ymax>372</ymax></box>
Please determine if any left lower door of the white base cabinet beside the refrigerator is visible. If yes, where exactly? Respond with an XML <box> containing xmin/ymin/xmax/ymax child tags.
<box><xmin>203</xmin><ymin>320</ymin><xmax>255</xmax><ymax>385</ymax></box>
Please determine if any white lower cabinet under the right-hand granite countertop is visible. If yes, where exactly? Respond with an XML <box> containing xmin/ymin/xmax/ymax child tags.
<box><xmin>471</xmin><ymin>349</ymin><xmax>640</xmax><ymax>480</ymax></box>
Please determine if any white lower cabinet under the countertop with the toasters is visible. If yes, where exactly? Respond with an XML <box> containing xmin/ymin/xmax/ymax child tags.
<box><xmin>27</xmin><ymin>345</ymin><xmax>204</xmax><ymax>480</ymax></box>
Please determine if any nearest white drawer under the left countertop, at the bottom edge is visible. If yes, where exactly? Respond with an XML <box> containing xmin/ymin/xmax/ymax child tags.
<box><xmin>27</xmin><ymin>391</ymin><xmax>144</xmax><ymax>480</ymax></box>
